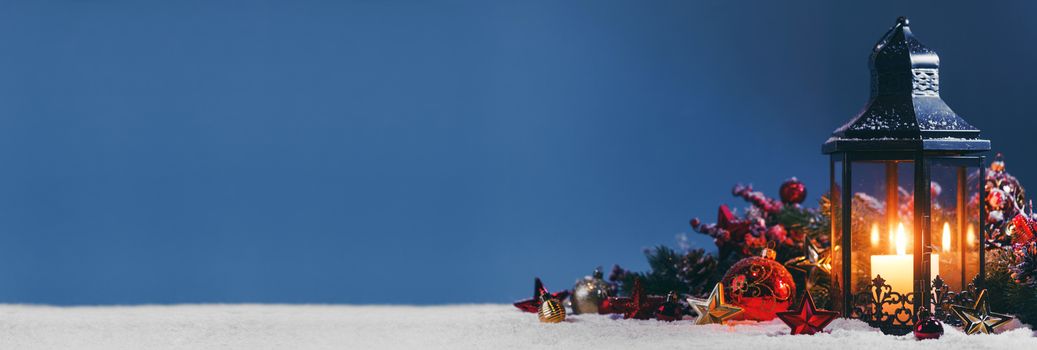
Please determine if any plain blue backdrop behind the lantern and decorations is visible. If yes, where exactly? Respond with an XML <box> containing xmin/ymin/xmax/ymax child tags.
<box><xmin>0</xmin><ymin>0</ymin><xmax>1037</xmax><ymax>304</ymax></box>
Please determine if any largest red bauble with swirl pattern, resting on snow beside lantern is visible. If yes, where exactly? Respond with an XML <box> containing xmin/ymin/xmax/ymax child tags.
<box><xmin>721</xmin><ymin>249</ymin><xmax>795</xmax><ymax>321</ymax></box>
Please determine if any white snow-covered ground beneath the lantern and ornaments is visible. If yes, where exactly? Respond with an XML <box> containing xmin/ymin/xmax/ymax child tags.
<box><xmin>0</xmin><ymin>304</ymin><xmax>1037</xmax><ymax>350</ymax></box>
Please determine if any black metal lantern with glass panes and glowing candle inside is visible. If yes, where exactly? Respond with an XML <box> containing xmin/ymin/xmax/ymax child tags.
<box><xmin>822</xmin><ymin>18</ymin><xmax>990</xmax><ymax>334</ymax></box>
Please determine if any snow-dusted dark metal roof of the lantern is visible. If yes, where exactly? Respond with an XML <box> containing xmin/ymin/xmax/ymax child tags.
<box><xmin>821</xmin><ymin>17</ymin><xmax>990</xmax><ymax>153</ymax></box>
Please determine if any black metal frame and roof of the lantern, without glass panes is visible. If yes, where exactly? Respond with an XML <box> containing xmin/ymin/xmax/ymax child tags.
<box><xmin>822</xmin><ymin>18</ymin><xmax>990</xmax><ymax>334</ymax></box>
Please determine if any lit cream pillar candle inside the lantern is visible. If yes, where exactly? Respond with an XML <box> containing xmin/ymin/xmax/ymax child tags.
<box><xmin>871</xmin><ymin>223</ymin><xmax>940</xmax><ymax>294</ymax></box>
